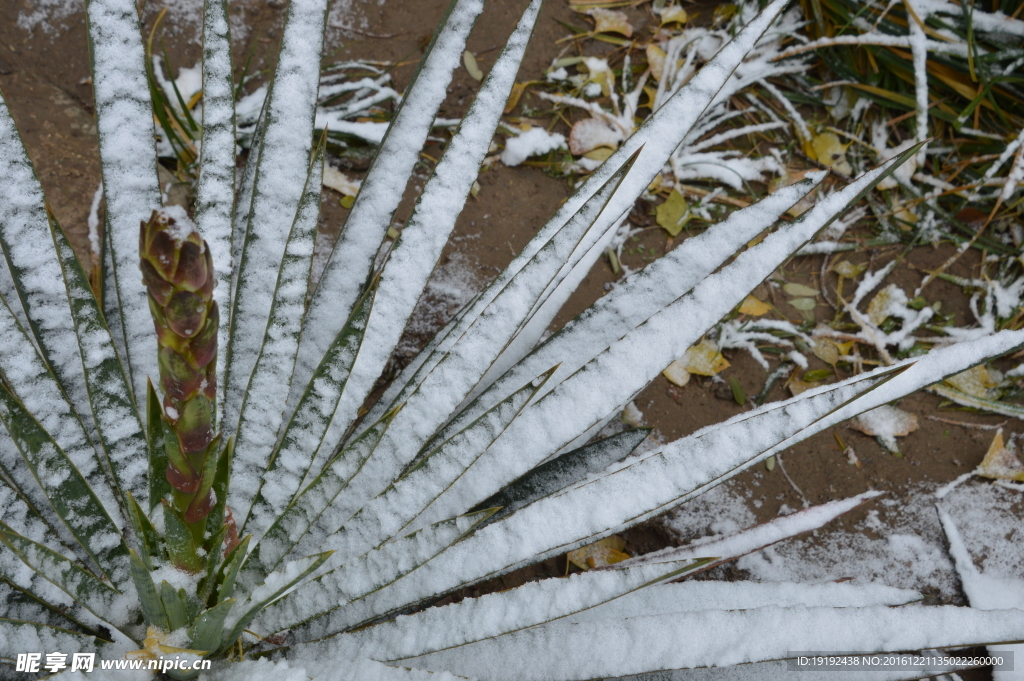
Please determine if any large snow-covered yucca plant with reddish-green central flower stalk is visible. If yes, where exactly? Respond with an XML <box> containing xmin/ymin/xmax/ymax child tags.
<box><xmin>0</xmin><ymin>0</ymin><xmax>1024</xmax><ymax>680</ymax></box>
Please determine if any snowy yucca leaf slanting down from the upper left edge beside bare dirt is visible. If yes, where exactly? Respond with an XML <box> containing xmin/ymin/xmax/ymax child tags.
<box><xmin>0</xmin><ymin>89</ymin><xmax>92</xmax><ymax>440</ymax></box>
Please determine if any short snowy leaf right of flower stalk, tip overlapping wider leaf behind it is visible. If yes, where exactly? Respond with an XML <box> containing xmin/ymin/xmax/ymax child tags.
<box><xmin>228</xmin><ymin>139</ymin><xmax>325</xmax><ymax>520</ymax></box>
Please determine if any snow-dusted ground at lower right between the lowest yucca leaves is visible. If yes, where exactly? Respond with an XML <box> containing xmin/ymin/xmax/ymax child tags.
<box><xmin>665</xmin><ymin>479</ymin><xmax>1024</xmax><ymax>602</ymax></box>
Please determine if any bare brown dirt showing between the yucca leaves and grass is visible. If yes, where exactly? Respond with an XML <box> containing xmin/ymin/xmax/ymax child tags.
<box><xmin>0</xmin><ymin>0</ymin><xmax>1022</xmax><ymax>671</ymax></box>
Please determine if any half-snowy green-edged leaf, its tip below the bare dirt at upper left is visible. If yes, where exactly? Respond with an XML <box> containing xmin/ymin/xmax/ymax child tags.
<box><xmin>50</xmin><ymin>218</ymin><xmax>148</xmax><ymax>504</ymax></box>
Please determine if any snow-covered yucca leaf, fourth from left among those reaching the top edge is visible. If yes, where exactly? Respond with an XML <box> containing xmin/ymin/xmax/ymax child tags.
<box><xmin>289</xmin><ymin>0</ymin><xmax>483</xmax><ymax>411</ymax></box>
